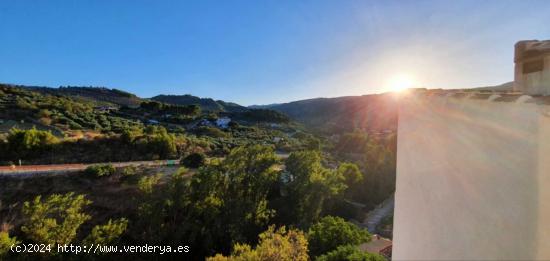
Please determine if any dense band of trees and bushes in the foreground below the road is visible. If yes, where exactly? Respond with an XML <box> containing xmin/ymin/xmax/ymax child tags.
<box><xmin>2</xmin><ymin>145</ymin><xmax>388</xmax><ymax>260</ymax></box>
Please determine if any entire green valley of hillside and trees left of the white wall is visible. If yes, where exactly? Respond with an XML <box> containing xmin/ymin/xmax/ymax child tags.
<box><xmin>0</xmin><ymin>85</ymin><xmax>396</xmax><ymax>260</ymax></box>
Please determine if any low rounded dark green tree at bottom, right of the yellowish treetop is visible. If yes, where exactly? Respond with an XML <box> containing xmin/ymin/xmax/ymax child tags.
<box><xmin>307</xmin><ymin>216</ymin><xmax>370</xmax><ymax>256</ymax></box>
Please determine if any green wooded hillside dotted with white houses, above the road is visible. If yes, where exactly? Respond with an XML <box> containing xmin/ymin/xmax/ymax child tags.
<box><xmin>0</xmin><ymin>85</ymin><xmax>314</xmax><ymax>165</ymax></box>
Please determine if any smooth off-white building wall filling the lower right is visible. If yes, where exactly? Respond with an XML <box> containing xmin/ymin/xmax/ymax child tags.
<box><xmin>393</xmin><ymin>96</ymin><xmax>550</xmax><ymax>260</ymax></box>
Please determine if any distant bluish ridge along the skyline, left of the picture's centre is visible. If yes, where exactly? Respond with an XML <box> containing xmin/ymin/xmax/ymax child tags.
<box><xmin>151</xmin><ymin>94</ymin><xmax>247</xmax><ymax>112</ymax></box>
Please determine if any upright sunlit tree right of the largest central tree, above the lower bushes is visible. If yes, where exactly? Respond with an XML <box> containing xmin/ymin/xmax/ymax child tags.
<box><xmin>283</xmin><ymin>151</ymin><xmax>347</xmax><ymax>227</ymax></box>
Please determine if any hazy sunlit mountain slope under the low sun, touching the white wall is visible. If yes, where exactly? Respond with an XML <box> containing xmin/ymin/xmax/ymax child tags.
<box><xmin>260</xmin><ymin>93</ymin><xmax>397</xmax><ymax>134</ymax></box>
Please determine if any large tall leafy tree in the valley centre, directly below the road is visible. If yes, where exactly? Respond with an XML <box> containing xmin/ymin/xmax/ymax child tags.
<box><xmin>180</xmin><ymin>145</ymin><xmax>279</xmax><ymax>255</ymax></box>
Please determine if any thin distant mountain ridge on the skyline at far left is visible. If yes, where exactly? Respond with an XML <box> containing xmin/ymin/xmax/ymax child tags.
<box><xmin>23</xmin><ymin>85</ymin><xmax>143</xmax><ymax>106</ymax></box>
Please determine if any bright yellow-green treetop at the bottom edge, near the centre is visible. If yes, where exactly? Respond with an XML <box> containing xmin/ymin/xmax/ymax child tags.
<box><xmin>207</xmin><ymin>226</ymin><xmax>309</xmax><ymax>261</ymax></box>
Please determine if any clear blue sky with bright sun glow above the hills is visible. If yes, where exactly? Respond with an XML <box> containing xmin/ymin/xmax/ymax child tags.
<box><xmin>0</xmin><ymin>0</ymin><xmax>550</xmax><ymax>105</ymax></box>
